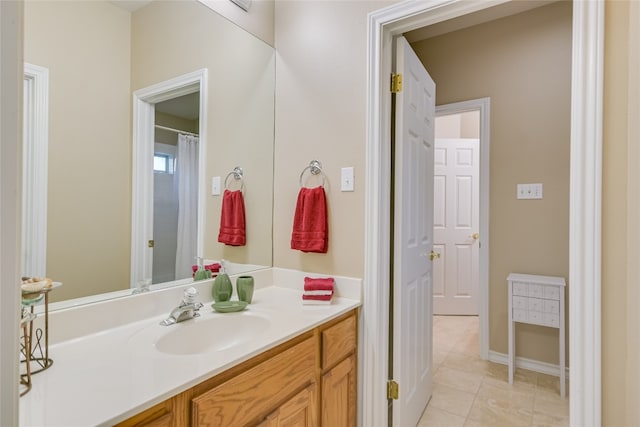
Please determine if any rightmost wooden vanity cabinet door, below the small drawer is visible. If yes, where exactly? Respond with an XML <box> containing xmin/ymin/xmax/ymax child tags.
<box><xmin>322</xmin><ymin>355</ymin><xmax>356</xmax><ymax>427</ymax></box>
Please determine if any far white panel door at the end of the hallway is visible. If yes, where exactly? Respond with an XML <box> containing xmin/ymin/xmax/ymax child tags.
<box><xmin>433</xmin><ymin>138</ymin><xmax>480</xmax><ymax>315</ymax></box>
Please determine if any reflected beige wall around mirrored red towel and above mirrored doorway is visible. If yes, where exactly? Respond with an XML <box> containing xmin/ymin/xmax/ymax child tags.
<box><xmin>131</xmin><ymin>2</ymin><xmax>275</xmax><ymax>265</ymax></box>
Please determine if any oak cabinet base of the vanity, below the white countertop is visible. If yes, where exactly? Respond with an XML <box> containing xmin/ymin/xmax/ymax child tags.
<box><xmin>118</xmin><ymin>310</ymin><xmax>357</xmax><ymax>427</ymax></box>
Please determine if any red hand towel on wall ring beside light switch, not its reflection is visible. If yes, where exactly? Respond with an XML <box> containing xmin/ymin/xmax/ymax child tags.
<box><xmin>291</xmin><ymin>186</ymin><xmax>329</xmax><ymax>254</ymax></box>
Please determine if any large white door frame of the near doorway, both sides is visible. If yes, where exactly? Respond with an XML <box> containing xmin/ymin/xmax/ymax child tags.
<box><xmin>359</xmin><ymin>0</ymin><xmax>604</xmax><ymax>425</ymax></box>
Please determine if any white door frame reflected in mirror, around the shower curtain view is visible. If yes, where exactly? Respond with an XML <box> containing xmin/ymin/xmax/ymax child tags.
<box><xmin>130</xmin><ymin>68</ymin><xmax>208</xmax><ymax>288</ymax></box>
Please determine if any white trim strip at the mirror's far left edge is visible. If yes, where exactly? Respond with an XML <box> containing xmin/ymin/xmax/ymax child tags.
<box><xmin>21</xmin><ymin>63</ymin><xmax>49</xmax><ymax>277</ymax></box>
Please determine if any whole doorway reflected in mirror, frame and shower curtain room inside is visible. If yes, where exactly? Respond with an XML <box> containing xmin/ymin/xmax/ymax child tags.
<box><xmin>131</xmin><ymin>69</ymin><xmax>207</xmax><ymax>290</ymax></box>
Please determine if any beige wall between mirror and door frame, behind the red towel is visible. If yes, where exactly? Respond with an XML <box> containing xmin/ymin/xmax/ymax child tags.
<box><xmin>273</xmin><ymin>1</ymin><xmax>391</xmax><ymax>277</ymax></box>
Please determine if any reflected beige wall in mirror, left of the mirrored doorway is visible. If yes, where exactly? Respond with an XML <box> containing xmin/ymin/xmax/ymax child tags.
<box><xmin>24</xmin><ymin>1</ymin><xmax>131</xmax><ymax>301</ymax></box>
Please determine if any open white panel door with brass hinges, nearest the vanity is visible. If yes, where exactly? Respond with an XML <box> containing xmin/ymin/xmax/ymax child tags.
<box><xmin>393</xmin><ymin>37</ymin><xmax>435</xmax><ymax>427</ymax></box>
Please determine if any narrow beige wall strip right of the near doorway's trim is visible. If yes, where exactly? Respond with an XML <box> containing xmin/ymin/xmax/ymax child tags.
<box><xmin>602</xmin><ymin>1</ymin><xmax>640</xmax><ymax>426</ymax></box>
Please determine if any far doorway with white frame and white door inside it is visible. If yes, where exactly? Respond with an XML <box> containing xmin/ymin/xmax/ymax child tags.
<box><xmin>433</xmin><ymin>98</ymin><xmax>491</xmax><ymax>360</ymax></box>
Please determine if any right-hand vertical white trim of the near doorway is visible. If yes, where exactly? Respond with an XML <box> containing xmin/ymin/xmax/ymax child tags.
<box><xmin>569</xmin><ymin>1</ymin><xmax>604</xmax><ymax>426</ymax></box>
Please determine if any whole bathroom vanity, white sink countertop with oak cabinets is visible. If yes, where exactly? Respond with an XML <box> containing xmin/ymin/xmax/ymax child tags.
<box><xmin>20</xmin><ymin>269</ymin><xmax>361</xmax><ymax>426</ymax></box>
